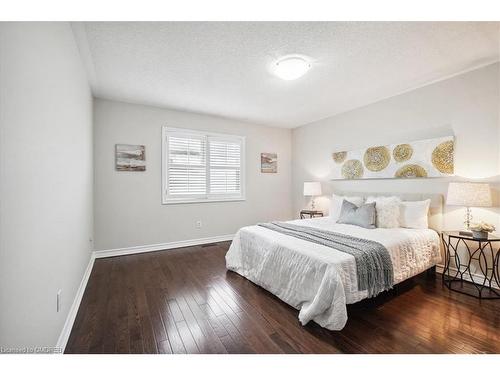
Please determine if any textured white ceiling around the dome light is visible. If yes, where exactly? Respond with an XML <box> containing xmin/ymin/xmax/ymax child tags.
<box><xmin>73</xmin><ymin>22</ymin><xmax>499</xmax><ymax>127</ymax></box>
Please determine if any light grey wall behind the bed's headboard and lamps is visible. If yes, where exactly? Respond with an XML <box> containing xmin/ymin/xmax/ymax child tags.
<box><xmin>292</xmin><ymin>63</ymin><xmax>500</xmax><ymax>229</ymax></box>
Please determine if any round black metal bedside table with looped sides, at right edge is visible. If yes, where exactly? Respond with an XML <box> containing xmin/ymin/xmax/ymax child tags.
<box><xmin>441</xmin><ymin>232</ymin><xmax>500</xmax><ymax>299</ymax></box>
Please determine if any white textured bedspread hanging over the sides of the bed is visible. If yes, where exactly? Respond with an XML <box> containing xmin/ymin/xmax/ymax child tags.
<box><xmin>226</xmin><ymin>217</ymin><xmax>441</xmax><ymax>330</ymax></box>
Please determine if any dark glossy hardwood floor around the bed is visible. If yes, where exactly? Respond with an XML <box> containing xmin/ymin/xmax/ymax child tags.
<box><xmin>66</xmin><ymin>242</ymin><xmax>500</xmax><ymax>353</ymax></box>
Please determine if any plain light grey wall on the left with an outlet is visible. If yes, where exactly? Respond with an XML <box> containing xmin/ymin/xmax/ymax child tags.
<box><xmin>0</xmin><ymin>23</ymin><xmax>93</xmax><ymax>348</ymax></box>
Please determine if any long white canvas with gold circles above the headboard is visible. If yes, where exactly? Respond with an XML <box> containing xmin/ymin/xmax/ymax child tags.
<box><xmin>332</xmin><ymin>136</ymin><xmax>455</xmax><ymax>180</ymax></box>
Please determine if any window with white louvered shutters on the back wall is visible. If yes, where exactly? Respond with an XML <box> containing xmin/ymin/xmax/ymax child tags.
<box><xmin>162</xmin><ymin>126</ymin><xmax>245</xmax><ymax>204</ymax></box>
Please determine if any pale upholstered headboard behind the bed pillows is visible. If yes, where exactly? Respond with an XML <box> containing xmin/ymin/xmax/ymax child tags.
<box><xmin>335</xmin><ymin>191</ymin><xmax>443</xmax><ymax>233</ymax></box>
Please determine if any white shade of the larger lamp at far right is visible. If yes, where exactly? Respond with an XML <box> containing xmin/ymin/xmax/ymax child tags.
<box><xmin>446</xmin><ymin>182</ymin><xmax>492</xmax><ymax>207</ymax></box>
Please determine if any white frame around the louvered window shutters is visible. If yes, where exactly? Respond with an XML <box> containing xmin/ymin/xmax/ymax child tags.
<box><xmin>161</xmin><ymin>125</ymin><xmax>246</xmax><ymax>205</ymax></box>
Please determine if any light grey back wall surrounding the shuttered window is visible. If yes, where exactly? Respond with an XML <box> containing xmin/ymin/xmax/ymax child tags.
<box><xmin>94</xmin><ymin>99</ymin><xmax>292</xmax><ymax>250</ymax></box>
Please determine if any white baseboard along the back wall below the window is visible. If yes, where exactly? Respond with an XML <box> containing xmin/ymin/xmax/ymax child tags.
<box><xmin>94</xmin><ymin>234</ymin><xmax>234</xmax><ymax>258</ymax></box>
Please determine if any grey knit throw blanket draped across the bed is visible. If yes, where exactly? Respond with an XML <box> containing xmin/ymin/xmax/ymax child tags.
<box><xmin>258</xmin><ymin>222</ymin><xmax>394</xmax><ymax>297</ymax></box>
